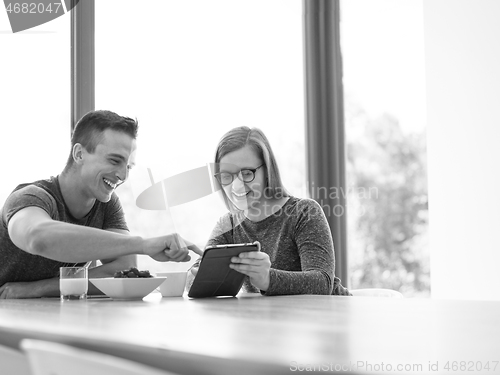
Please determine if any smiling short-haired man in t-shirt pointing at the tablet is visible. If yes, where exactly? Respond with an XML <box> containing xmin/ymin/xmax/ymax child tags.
<box><xmin>0</xmin><ymin>111</ymin><xmax>201</xmax><ymax>298</ymax></box>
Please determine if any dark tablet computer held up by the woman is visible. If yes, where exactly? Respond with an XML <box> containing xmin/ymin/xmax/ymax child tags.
<box><xmin>188</xmin><ymin>242</ymin><xmax>260</xmax><ymax>298</ymax></box>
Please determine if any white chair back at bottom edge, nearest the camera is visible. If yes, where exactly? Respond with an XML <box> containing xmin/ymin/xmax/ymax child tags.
<box><xmin>21</xmin><ymin>339</ymin><xmax>181</xmax><ymax>375</ymax></box>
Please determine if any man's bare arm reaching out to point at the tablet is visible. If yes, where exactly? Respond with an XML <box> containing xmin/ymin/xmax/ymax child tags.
<box><xmin>8</xmin><ymin>207</ymin><xmax>199</xmax><ymax>263</ymax></box>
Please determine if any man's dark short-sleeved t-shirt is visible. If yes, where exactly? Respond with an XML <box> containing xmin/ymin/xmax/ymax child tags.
<box><xmin>0</xmin><ymin>177</ymin><xmax>128</xmax><ymax>285</ymax></box>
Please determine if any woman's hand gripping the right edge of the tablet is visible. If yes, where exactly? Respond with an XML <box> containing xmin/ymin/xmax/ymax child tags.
<box><xmin>229</xmin><ymin>251</ymin><xmax>271</xmax><ymax>292</ymax></box>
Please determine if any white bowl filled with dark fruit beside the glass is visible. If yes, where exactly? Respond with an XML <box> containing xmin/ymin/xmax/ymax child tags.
<box><xmin>89</xmin><ymin>277</ymin><xmax>166</xmax><ymax>299</ymax></box>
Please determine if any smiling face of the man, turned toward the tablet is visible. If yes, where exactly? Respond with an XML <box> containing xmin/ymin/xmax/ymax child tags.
<box><xmin>81</xmin><ymin>129</ymin><xmax>136</xmax><ymax>206</ymax></box>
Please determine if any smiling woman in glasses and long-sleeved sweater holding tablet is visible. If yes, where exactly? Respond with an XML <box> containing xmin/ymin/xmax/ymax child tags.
<box><xmin>188</xmin><ymin>127</ymin><xmax>349</xmax><ymax>295</ymax></box>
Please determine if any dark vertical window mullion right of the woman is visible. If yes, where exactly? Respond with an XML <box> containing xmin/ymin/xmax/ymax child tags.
<box><xmin>303</xmin><ymin>0</ymin><xmax>348</xmax><ymax>285</ymax></box>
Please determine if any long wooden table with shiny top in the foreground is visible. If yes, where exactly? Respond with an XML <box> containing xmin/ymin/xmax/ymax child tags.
<box><xmin>0</xmin><ymin>293</ymin><xmax>500</xmax><ymax>375</ymax></box>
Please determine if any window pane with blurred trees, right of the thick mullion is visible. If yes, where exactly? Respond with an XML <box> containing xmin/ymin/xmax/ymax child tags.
<box><xmin>341</xmin><ymin>0</ymin><xmax>430</xmax><ymax>296</ymax></box>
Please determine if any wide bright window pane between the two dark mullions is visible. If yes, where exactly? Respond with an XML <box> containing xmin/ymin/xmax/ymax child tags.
<box><xmin>95</xmin><ymin>0</ymin><xmax>307</xmax><ymax>271</ymax></box>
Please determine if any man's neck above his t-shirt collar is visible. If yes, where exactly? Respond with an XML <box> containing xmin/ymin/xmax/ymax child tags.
<box><xmin>59</xmin><ymin>170</ymin><xmax>95</xmax><ymax>219</ymax></box>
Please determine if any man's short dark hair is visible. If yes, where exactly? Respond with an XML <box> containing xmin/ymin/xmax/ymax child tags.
<box><xmin>65</xmin><ymin>111</ymin><xmax>139</xmax><ymax>170</ymax></box>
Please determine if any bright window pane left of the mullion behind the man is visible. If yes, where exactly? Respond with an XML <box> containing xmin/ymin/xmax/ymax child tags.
<box><xmin>0</xmin><ymin>12</ymin><xmax>71</xmax><ymax>205</ymax></box>
